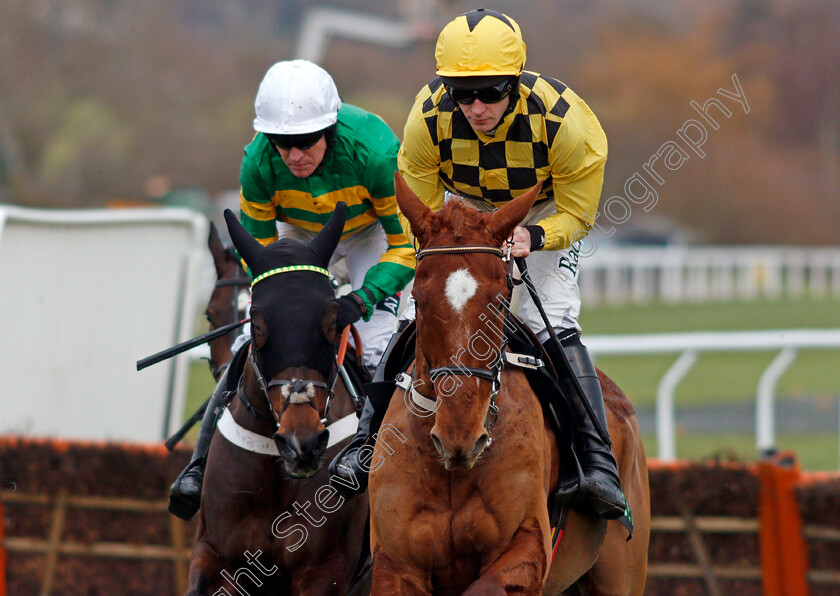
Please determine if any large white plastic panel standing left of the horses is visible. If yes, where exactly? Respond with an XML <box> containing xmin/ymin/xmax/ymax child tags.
<box><xmin>0</xmin><ymin>207</ymin><xmax>207</xmax><ymax>442</ymax></box>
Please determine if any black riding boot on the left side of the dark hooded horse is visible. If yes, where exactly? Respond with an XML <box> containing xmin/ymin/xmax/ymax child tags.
<box><xmin>169</xmin><ymin>352</ymin><xmax>240</xmax><ymax>520</ymax></box>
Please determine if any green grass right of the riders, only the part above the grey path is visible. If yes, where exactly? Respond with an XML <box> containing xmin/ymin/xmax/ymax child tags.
<box><xmin>581</xmin><ymin>300</ymin><xmax>840</xmax><ymax>406</ymax></box>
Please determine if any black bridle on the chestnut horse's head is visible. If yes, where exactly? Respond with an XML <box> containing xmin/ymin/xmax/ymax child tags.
<box><xmin>415</xmin><ymin>244</ymin><xmax>516</xmax><ymax>428</ymax></box>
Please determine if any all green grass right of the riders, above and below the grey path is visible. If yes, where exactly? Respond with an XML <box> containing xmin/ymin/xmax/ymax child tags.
<box><xmin>581</xmin><ymin>299</ymin><xmax>840</xmax><ymax>470</ymax></box>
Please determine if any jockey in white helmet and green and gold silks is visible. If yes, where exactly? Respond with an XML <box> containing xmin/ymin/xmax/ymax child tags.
<box><xmin>169</xmin><ymin>60</ymin><xmax>414</xmax><ymax>519</ymax></box>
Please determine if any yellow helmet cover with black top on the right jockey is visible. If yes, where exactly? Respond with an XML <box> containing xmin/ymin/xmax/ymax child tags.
<box><xmin>435</xmin><ymin>8</ymin><xmax>525</xmax><ymax>77</ymax></box>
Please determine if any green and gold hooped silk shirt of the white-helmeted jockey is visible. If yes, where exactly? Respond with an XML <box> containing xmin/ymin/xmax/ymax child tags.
<box><xmin>240</xmin><ymin>104</ymin><xmax>414</xmax><ymax>320</ymax></box>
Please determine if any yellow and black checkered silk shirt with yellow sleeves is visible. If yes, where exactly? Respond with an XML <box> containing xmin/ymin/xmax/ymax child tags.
<box><xmin>399</xmin><ymin>71</ymin><xmax>607</xmax><ymax>250</ymax></box>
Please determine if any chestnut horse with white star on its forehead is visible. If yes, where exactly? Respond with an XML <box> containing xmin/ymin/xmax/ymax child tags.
<box><xmin>369</xmin><ymin>176</ymin><xmax>650</xmax><ymax>596</ymax></box>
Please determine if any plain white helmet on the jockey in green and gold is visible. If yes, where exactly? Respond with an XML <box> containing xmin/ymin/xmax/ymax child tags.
<box><xmin>254</xmin><ymin>60</ymin><xmax>341</xmax><ymax>135</ymax></box>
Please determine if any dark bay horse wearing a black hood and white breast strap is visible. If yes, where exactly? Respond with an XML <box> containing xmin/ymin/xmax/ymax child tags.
<box><xmin>188</xmin><ymin>203</ymin><xmax>368</xmax><ymax>596</ymax></box>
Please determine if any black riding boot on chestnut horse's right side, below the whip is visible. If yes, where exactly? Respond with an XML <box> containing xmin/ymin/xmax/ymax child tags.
<box><xmin>543</xmin><ymin>334</ymin><xmax>627</xmax><ymax>519</ymax></box>
